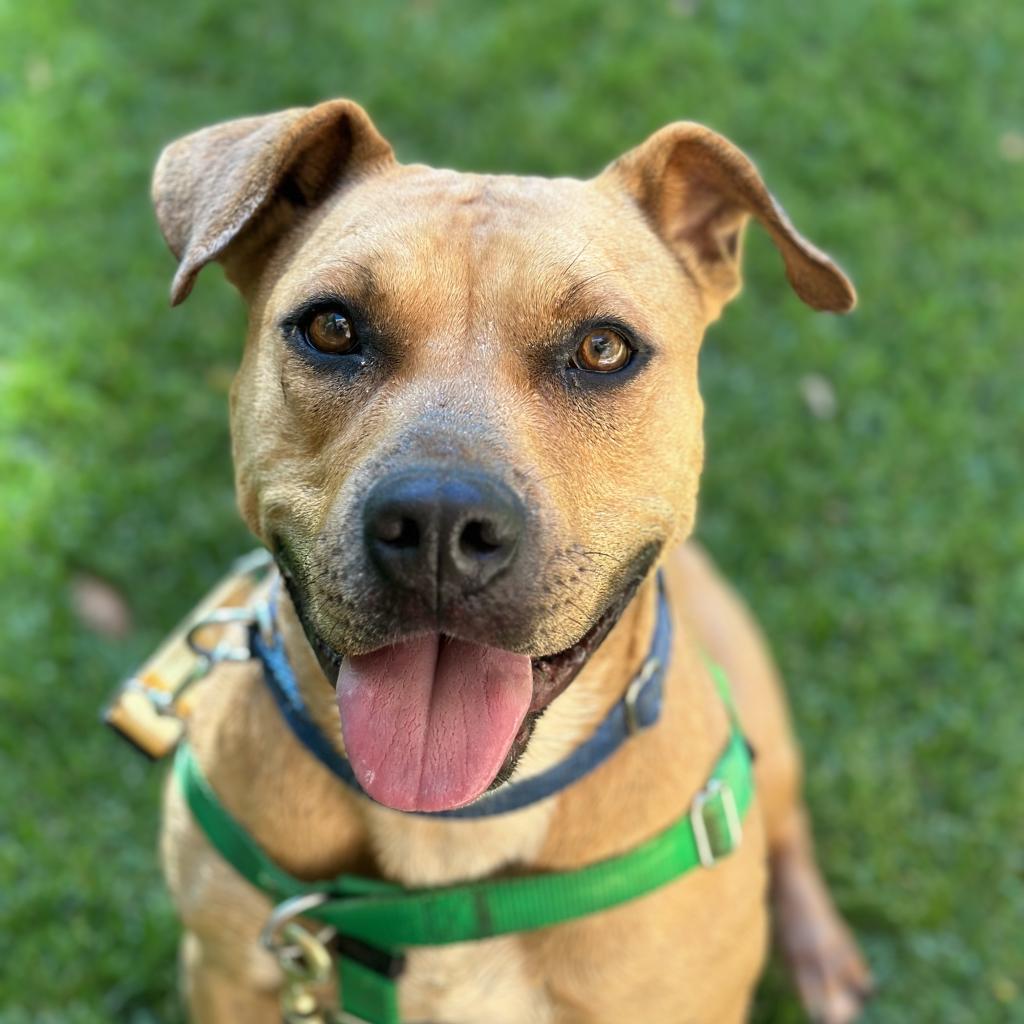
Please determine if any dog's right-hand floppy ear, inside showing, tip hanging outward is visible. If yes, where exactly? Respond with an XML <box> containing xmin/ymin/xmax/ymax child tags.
<box><xmin>602</xmin><ymin>121</ymin><xmax>857</xmax><ymax>321</ymax></box>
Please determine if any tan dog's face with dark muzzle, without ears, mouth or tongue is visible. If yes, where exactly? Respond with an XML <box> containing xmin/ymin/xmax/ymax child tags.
<box><xmin>232</xmin><ymin>167</ymin><xmax>702</xmax><ymax>656</ymax></box>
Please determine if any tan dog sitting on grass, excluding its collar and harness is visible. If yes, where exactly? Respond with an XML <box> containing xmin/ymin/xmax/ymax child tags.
<box><xmin>154</xmin><ymin>100</ymin><xmax>869</xmax><ymax>1024</ymax></box>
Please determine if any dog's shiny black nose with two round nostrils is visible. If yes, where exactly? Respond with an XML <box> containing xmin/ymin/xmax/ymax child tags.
<box><xmin>362</xmin><ymin>467</ymin><xmax>525</xmax><ymax>607</ymax></box>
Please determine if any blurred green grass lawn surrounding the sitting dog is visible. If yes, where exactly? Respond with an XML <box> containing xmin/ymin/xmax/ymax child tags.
<box><xmin>0</xmin><ymin>0</ymin><xmax>1024</xmax><ymax>1024</ymax></box>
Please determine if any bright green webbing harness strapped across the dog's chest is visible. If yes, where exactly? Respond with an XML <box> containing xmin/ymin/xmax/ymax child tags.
<box><xmin>174</xmin><ymin>665</ymin><xmax>754</xmax><ymax>1024</ymax></box>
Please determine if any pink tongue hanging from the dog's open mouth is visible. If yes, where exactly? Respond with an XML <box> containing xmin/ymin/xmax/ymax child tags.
<box><xmin>338</xmin><ymin>633</ymin><xmax>534</xmax><ymax>811</ymax></box>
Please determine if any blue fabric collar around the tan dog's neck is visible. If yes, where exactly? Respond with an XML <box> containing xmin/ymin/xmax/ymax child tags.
<box><xmin>250</xmin><ymin>572</ymin><xmax>672</xmax><ymax>818</ymax></box>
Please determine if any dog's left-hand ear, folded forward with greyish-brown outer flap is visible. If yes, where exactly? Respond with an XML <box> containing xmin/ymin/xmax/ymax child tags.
<box><xmin>153</xmin><ymin>99</ymin><xmax>394</xmax><ymax>305</ymax></box>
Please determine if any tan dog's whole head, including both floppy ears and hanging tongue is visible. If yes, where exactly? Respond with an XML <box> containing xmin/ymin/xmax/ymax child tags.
<box><xmin>155</xmin><ymin>101</ymin><xmax>853</xmax><ymax>810</ymax></box>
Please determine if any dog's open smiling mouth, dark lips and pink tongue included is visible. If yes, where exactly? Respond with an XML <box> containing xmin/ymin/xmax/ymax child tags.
<box><xmin>279</xmin><ymin>553</ymin><xmax>653</xmax><ymax>812</ymax></box>
